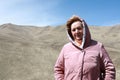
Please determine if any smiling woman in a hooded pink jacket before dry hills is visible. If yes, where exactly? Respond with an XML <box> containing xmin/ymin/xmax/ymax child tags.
<box><xmin>54</xmin><ymin>16</ymin><xmax>115</xmax><ymax>80</ymax></box>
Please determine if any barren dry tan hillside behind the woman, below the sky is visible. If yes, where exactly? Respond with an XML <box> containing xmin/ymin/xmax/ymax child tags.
<box><xmin>0</xmin><ymin>24</ymin><xmax>120</xmax><ymax>80</ymax></box>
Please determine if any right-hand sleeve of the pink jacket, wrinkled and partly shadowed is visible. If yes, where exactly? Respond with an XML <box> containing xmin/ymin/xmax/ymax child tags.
<box><xmin>100</xmin><ymin>45</ymin><xmax>116</xmax><ymax>80</ymax></box>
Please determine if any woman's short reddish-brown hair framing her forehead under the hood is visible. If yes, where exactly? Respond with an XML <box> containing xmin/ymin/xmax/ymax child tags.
<box><xmin>66</xmin><ymin>15</ymin><xmax>82</xmax><ymax>40</ymax></box>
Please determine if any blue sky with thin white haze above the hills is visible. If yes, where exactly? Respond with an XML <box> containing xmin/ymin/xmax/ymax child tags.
<box><xmin>0</xmin><ymin>0</ymin><xmax>120</xmax><ymax>26</ymax></box>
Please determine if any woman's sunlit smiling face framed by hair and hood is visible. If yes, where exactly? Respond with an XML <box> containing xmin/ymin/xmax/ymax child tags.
<box><xmin>71</xmin><ymin>21</ymin><xmax>83</xmax><ymax>41</ymax></box>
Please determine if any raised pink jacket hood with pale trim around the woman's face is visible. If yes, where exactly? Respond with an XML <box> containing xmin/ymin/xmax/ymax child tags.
<box><xmin>67</xmin><ymin>18</ymin><xmax>91</xmax><ymax>49</ymax></box>
